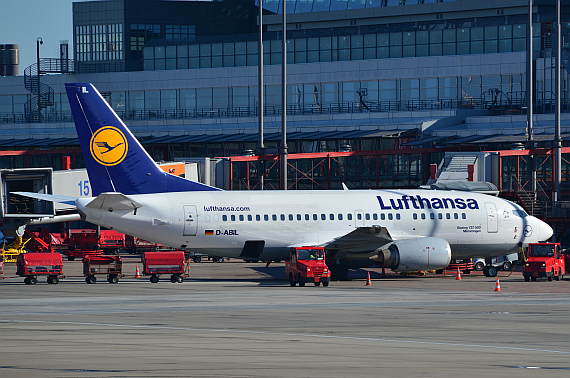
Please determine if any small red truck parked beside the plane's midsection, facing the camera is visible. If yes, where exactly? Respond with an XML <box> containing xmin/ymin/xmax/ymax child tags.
<box><xmin>285</xmin><ymin>247</ymin><xmax>331</xmax><ymax>286</ymax></box>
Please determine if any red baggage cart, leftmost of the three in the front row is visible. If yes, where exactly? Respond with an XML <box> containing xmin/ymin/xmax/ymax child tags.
<box><xmin>16</xmin><ymin>253</ymin><xmax>63</xmax><ymax>285</ymax></box>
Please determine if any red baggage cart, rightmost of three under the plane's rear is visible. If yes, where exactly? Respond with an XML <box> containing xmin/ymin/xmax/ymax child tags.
<box><xmin>142</xmin><ymin>251</ymin><xmax>186</xmax><ymax>283</ymax></box>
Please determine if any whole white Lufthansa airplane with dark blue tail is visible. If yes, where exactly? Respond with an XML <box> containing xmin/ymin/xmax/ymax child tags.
<box><xmin>14</xmin><ymin>83</ymin><xmax>553</xmax><ymax>279</ymax></box>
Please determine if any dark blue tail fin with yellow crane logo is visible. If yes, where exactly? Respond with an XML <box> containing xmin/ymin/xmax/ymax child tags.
<box><xmin>65</xmin><ymin>83</ymin><xmax>219</xmax><ymax>196</ymax></box>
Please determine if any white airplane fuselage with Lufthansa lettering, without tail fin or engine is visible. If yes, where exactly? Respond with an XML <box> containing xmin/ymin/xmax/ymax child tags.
<box><xmin>77</xmin><ymin>190</ymin><xmax>552</xmax><ymax>260</ymax></box>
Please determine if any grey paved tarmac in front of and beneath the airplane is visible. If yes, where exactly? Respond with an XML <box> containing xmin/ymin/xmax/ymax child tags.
<box><xmin>0</xmin><ymin>256</ymin><xmax>570</xmax><ymax>378</ymax></box>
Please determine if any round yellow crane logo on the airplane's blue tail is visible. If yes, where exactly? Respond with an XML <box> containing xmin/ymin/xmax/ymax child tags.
<box><xmin>90</xmin><ymin>126</ymin><xmax>129</xmax><ymax>166</ymax></box>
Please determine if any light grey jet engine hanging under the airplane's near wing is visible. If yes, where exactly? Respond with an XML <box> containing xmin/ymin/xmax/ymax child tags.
<box><xmin>375</xmin><ymin>237</ymin><xmax>451</xmax><ymax>272</ymax></box>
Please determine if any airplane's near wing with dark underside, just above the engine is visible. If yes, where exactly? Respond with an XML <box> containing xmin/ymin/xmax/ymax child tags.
<box><xmin>323</xmin><ymin>227</ymin><xmax>414</xmax><ymax>259</ymax></box>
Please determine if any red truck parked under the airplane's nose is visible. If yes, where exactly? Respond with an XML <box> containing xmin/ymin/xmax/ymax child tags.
<box><xmin>523</xmin><ymin>243</ymin><xmax>566</xmax><ymax>281</ymax></box>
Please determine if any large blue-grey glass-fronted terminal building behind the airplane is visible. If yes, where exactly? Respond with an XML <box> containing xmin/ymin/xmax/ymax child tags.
<box><xmin>0</xmin><ymin>0</ymin><xmax>570</xmax><ymax>207</ymax></box>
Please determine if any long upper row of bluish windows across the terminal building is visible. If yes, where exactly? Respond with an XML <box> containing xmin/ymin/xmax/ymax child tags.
<box><xmin>143</xmin><ymin>24</ymin><xmax>541</xmax><ymax>71</ymax></box>
